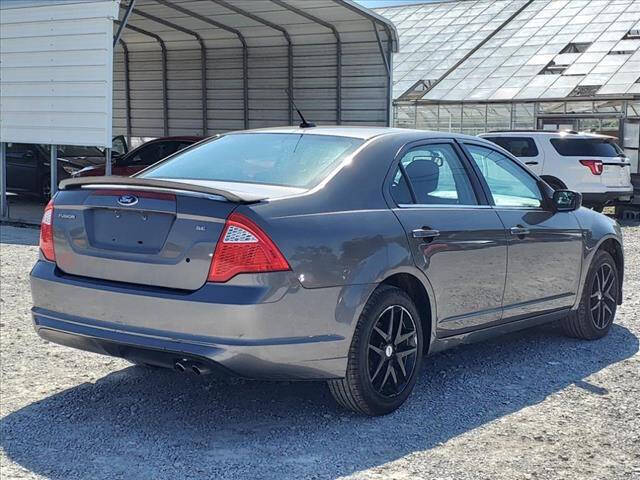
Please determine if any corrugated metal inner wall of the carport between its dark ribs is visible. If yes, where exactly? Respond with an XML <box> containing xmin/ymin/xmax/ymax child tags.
<box><xmin>113</xmin><ymin>0</ymin><xmax>390</xmax><ymax>137</ymax></box>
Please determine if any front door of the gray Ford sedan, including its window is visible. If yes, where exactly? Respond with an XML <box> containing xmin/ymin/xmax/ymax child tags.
<box><xmin>465</xmin><ymin>142</ymin><xmax>582</xmax><ymax>320</ymax></box>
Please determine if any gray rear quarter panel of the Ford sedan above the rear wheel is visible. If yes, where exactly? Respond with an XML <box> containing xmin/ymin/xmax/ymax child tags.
<box><xmin>238</xmin><ymin>137</ymin><xmax>415</xmax><ymax>288</ymax></box>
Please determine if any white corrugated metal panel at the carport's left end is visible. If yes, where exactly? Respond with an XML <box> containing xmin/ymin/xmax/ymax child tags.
<box><xmin>0</xmin><ymin>0</ymin><xmax>118</xmax><ymax>146</ymax></box>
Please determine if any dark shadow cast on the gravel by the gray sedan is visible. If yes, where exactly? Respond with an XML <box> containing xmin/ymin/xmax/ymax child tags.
<box><xmin>0</xmin><ymin>325</ymin><xmax>638</xmax><ymax>480</ymax></box>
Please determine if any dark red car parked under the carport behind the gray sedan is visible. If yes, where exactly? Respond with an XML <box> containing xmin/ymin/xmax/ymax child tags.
<box><xmin>74</xmin><ymin>137</ymin><xmax>203</xmax><ymax>177</ymax></box>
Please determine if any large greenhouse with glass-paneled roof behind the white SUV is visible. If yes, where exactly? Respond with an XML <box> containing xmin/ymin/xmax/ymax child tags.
<box><xmin>376</xmin><ymin>0</ymin><xmax>640</xmax><ymax>173</ymax></box>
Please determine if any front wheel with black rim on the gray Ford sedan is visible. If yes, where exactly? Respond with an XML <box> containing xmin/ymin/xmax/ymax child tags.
<box><xmin>562</xmin><ymin>251</ymin><xmax>620</xmax><ymax>340</ymax></box>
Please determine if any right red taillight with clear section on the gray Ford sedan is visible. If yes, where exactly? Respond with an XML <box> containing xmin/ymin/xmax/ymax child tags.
<box><xmin>207</xmin><ymin>213</ymin><xmax>290</xmax><ymax>282</ymax></box>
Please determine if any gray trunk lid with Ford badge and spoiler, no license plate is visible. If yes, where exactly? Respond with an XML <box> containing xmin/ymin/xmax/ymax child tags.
<box><xmin>53</xmin><ymin>177</ymin><xmax>263</xmax><ymax>290</ymax></box>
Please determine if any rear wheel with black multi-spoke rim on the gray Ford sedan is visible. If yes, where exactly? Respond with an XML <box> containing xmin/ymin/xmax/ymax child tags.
<box><xmin>328</xmin><ymin>286</ymin><xmax>424</xmax><ymax>416</ymax></box>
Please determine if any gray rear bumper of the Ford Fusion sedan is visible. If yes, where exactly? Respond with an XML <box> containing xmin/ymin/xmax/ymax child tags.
<box><xmin>31</xmin><ymin>260</ymin><xmax>374</xmax><ymax>379</ymax></box>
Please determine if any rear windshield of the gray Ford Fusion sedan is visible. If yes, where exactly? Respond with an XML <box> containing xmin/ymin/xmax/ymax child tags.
<box><xmin>140</xmin><ymin>133</ymin><xmax>364</xmax><ymax>188</ymax></box>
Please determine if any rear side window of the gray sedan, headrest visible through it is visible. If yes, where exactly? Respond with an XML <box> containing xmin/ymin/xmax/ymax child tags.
<box><xmin>391</xmin><ymin>143</ymin><xmax>478</xmax><ymax>205</ymax></box>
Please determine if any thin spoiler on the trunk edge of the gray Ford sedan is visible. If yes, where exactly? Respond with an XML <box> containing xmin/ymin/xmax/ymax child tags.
<box><xmin>60</xmin><ymin>176</ymin><xmax>265</xmax><ymax>203</ymax></box>
